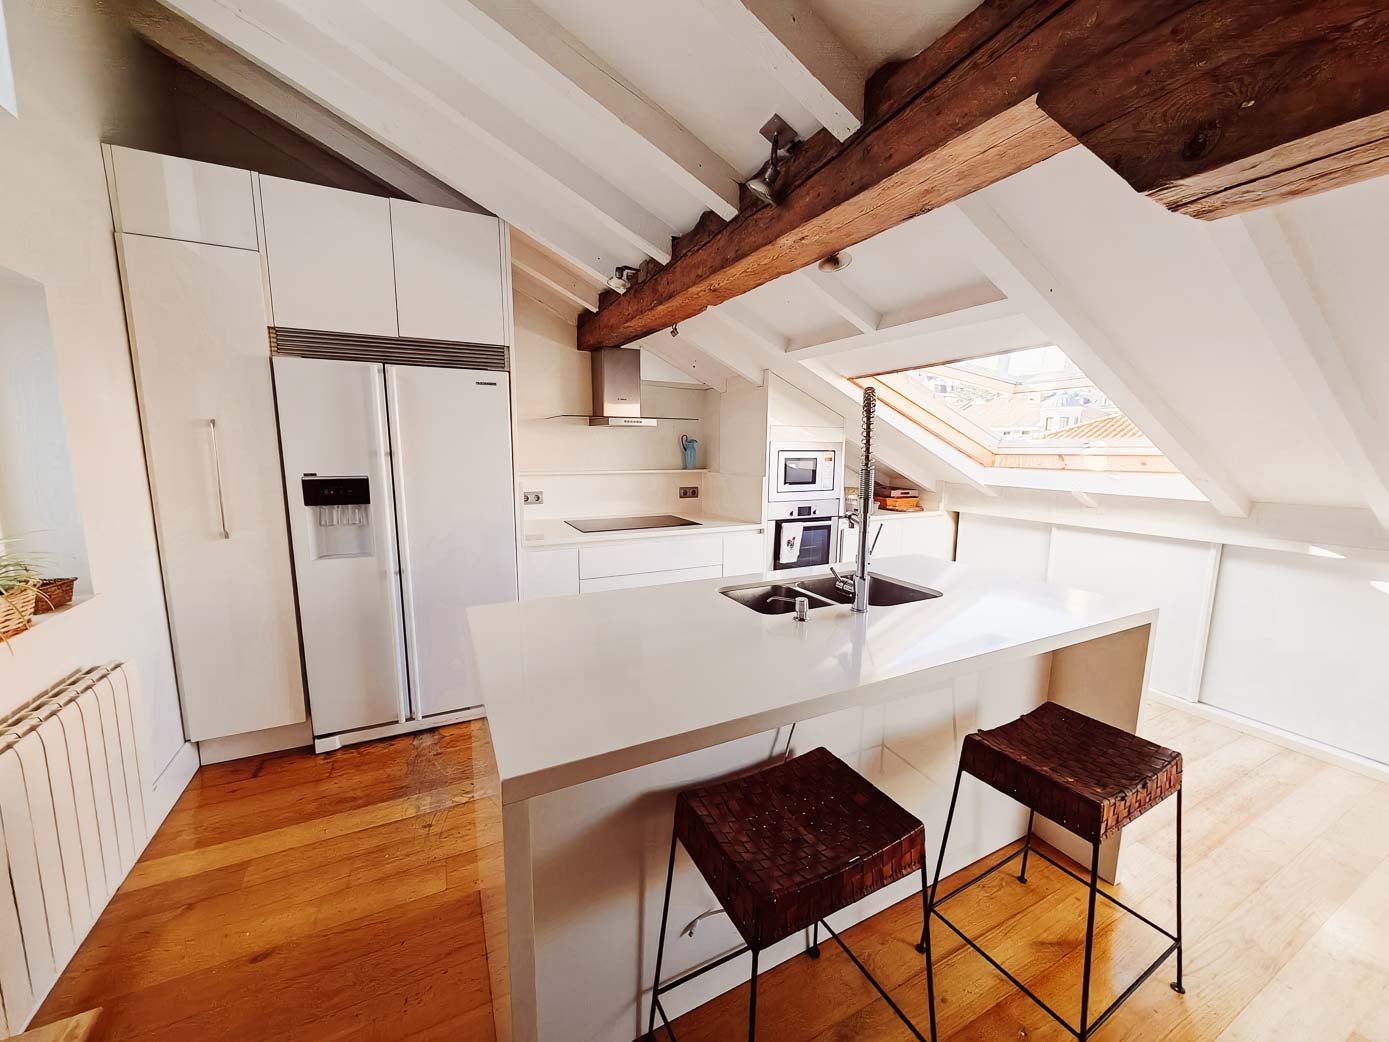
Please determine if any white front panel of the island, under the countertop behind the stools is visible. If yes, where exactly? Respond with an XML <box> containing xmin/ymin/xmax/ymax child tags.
<box><xmin>507</xmin><ymin>654</ymin><xmax>1051</xmax><ymax>1042</ymax></box>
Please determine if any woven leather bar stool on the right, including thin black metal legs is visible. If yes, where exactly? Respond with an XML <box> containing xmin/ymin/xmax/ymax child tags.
<box><xmin>922</xmin><ymin>702</ymin><xmax>1186</xmax><ymax>1042</ymax></box>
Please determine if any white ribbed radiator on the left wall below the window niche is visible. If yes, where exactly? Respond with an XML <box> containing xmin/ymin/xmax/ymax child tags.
<box><xmin>0</xmin><ymin>664</ymin><xmax>149</xmax><ymax>1038</ymax></box>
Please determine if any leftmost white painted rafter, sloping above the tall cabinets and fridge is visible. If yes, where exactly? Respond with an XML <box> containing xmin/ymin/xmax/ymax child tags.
<box><xmin>161</xmin><ymin>0</ymin><xmax>636</xmax><ymax>279</ymax></box>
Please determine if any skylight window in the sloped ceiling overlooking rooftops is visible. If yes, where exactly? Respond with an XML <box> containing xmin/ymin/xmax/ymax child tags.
<box><xmin>854</xmin><ymin>346</ymin><xmax>1176</xmax><ymax>474</ymax></box>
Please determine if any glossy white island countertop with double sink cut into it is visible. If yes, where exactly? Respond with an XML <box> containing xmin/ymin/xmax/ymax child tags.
<box><xmin>468</xmin><ymin>558</ymin><xmax>1157</xmax><ymax>803</ymax></box>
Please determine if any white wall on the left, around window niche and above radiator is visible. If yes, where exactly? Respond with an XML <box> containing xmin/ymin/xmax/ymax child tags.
<box><xmin>0</xmin><ymin>0</ymin><xmax>183</xmax><ymax>800</ymax></box>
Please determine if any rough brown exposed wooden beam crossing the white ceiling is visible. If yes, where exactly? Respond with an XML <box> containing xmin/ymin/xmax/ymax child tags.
<box><xmin>579</xmin><ymin>0</ymin><xmax>1389</xmax><ymax>349</ymax></box>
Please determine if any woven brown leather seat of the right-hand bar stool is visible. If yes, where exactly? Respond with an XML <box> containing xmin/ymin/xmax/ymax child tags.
<box><xmin>960</xmin><ymin>702</ymin><xmax>1182</xmax><ymax>842</ymax></box>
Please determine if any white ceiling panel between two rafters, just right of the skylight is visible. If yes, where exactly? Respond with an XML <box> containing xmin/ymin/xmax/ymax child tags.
<box><xmin>983</xmin><ymin>149</ymin><xmax>1361</xmax><ymax>506</ymax></box>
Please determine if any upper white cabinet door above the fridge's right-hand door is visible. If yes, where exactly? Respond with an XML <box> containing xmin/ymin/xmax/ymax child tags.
<box><xmin>390</xmin><ymin>199</ymin><xmax>510</xmax><ymax>345</ymax></box>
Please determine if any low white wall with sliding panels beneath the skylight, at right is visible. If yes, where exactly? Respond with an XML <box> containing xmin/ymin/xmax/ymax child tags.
<box><xmin>957</xmin><ymin>511</ymin><xmax>1389</xmax><ymax>764</ymax></box>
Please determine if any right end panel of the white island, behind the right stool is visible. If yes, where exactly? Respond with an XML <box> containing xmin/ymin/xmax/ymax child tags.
<box><xmin>1035</xmin><ymin>625</ymin><xmax>1153</xmax><ymax>882</ymax></box>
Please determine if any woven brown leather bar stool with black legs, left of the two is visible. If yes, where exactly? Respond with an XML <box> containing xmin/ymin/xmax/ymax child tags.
<box><xmin>646</xmin><ymin>749</ymin><xmax>936</xmax><ymax>1042</ymax></box>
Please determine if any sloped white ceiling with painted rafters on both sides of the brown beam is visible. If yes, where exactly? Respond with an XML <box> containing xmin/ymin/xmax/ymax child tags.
<box><xmin>160</xmin><ymin>0</ymin><xmax>1389</xmax><ymax>524</ymax></box>
